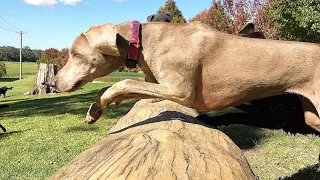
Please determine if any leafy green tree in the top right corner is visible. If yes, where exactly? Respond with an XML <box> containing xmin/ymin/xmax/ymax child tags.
<box><xmin>267</xmin><ymin>0</ymin><xmax>320</xmax><ymax>43</ymax></box>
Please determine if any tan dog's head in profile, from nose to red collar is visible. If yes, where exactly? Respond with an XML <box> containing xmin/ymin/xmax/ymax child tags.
<box><xmin>51</xmin><ymin>24</ymin><xmax>122</xmax><ymax>92</ymax></box>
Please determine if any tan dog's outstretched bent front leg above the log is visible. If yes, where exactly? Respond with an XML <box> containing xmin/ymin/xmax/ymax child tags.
<box><xmin>85</xmin><ymin>80</ymin><xmax>195</xmax><ymax>124</ymax></box>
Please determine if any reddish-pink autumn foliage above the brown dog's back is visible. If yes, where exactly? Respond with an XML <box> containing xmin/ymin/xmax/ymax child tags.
<box><xmin>190</xmin><ymin>0</ymin><xmax>276</xmax><ymax>38</ymax></box>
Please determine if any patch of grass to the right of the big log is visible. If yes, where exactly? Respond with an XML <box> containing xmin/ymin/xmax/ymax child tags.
<box><xmin>220</xmin><ymin>125</ymin><xmax>320</xmax><ymax>180</ymax></box>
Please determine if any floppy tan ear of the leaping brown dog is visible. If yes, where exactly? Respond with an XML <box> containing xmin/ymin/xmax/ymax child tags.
<box><xmin>83</xmin><ymin>23</ymin><xmax>120</xmax><ymax>56</ymax></box>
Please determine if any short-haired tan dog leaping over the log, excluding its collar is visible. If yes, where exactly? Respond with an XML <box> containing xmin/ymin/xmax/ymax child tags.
<box><xmin>55</xmin><ymin>22</ymin><xmax>320</xmax><ymax>131</ymax></box>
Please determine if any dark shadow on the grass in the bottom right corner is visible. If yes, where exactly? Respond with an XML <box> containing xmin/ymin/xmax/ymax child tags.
<box><xmin>280</xmin><ymin>163</ymin><xmax>320</xmax><ymax>180</ymax></box>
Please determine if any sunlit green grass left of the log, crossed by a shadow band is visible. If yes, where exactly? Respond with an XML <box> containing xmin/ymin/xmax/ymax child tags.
<box><xmin>0</xmin><ymin>76</ymin><xmax>136</xmax><ymax>179</ymax></box>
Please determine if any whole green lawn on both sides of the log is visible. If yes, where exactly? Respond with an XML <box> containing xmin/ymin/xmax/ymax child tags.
<box><xmin>0</xmin><ymin>63</ymin><xmax>320</xmax><ymax>179</ymax></box>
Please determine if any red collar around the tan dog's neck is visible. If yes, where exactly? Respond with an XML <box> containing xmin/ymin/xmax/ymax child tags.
<box><xmin>126</xmin><ymin>21</ymin><xmax>140</xmax><ymax>68</ymax></box>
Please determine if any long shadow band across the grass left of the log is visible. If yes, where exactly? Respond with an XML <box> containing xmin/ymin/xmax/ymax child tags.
<box><xmin>0</xmin><ymin>90</ymin><xmax>133</xmax><ymax>118</ymax></box>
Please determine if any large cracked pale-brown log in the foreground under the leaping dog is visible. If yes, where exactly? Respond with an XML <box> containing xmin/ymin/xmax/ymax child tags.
<box><xmin>51</xmin><ymin>100</ymin><xmax>255</xmax><ymax>180</ymax></box>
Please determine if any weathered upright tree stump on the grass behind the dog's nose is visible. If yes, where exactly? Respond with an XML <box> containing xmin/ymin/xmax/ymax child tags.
<box><xmin>24</xmin><ymin>63</ymin><xmax>58</xmax><ymax>96</ymax></box>
